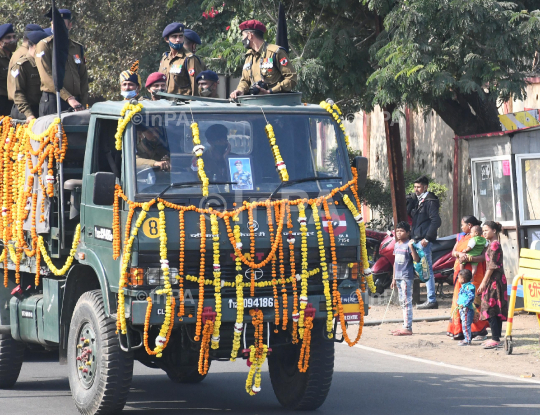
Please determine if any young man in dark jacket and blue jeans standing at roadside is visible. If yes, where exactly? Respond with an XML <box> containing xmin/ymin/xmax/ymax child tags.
<box><xmin>407</xmin><ymin>176</ymin><xmax>441</xmax><ymax>310</ymax></box>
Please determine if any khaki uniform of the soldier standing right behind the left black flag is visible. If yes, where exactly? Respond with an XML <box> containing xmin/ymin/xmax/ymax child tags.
<box><xmin>36</xmin><ymin>36</ymin><xmax>88</xmax><ymax>107</ymax></box>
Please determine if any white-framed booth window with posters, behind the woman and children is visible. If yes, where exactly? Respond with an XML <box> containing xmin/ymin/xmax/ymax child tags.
<box><xmin>471</xmin><ymin>156</ymin><xmax>516</xmax><ymax>226</ymax></box>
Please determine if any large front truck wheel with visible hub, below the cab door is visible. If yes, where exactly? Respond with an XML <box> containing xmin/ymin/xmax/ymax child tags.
<box><xmin>67</xmin><ymin>290</ymin><xmax>133</xmax><ymax>415</ymax></box>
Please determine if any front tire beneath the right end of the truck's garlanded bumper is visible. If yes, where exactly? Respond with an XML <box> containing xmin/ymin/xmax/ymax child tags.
<box><xmin>268</xmin><ymin>321</ymin><xmax>334</xmax><ymax>411</ymax></box>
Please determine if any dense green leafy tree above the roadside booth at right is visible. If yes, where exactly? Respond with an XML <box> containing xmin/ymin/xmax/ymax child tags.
<box><xmin>368</xmin><ymin>0</ymin><xmax>540</xmax><ymax>135</ymax></box>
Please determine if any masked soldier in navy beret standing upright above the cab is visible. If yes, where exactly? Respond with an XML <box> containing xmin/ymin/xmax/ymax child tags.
<box><xmin>159</xmin><ymin>22</ymin><xmax>191</xmax><ymax>95</ymax></box>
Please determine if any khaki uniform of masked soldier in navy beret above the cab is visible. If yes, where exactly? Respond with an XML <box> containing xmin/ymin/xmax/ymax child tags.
<box><xmin>159</xmin><ymin>49</ymin><xmax>206</xmax><ymax>96</ymax></box>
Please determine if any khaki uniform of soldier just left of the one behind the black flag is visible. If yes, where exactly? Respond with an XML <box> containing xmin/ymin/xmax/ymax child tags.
<box><xmin>9</xmin><ymin>55</ymin><xmax>41</xmax><ymax>118</ymax></box>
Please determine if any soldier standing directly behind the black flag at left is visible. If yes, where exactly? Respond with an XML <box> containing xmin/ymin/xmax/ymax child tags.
<box><xmin>36</xmin><ymin>9</ymin><xmax>88</xmax><ymax>116</ymax></box>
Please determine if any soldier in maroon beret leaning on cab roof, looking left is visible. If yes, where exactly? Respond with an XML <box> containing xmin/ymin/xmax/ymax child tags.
<box><xmin>231</xmin><ymin>20</ymin><xmax>296</xmax><ymax>99</ymax></box>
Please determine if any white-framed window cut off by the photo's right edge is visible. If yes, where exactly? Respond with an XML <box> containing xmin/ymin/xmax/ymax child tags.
<box><xmin>516</xmin><ymin>154</ymin><xmax>540</xmax><ymax>225</ymax></box>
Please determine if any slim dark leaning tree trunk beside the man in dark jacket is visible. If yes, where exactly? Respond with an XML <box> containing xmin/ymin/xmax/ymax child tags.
<box><xmin>383</xmin><ymin>104</ymin><xmax>407</xmax><ymax>227</ymax></box>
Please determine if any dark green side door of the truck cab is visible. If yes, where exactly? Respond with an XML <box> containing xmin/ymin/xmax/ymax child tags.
<box><xmin>81</xmin><ymin>117</ymin><xmax>122</xmax><ymax>285</ymax></box>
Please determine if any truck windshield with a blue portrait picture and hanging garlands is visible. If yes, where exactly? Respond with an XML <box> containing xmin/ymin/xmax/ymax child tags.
<box><xmin>134</xmin><ymin>114</ymin><xmax>350</xmax><ymax>195</ymax></box>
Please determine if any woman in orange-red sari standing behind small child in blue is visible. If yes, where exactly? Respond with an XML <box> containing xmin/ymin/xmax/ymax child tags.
<box><xmin>447</xmin><ymin>216</ymin><xmax>489</xmax><ymax>340</ymax></box>
